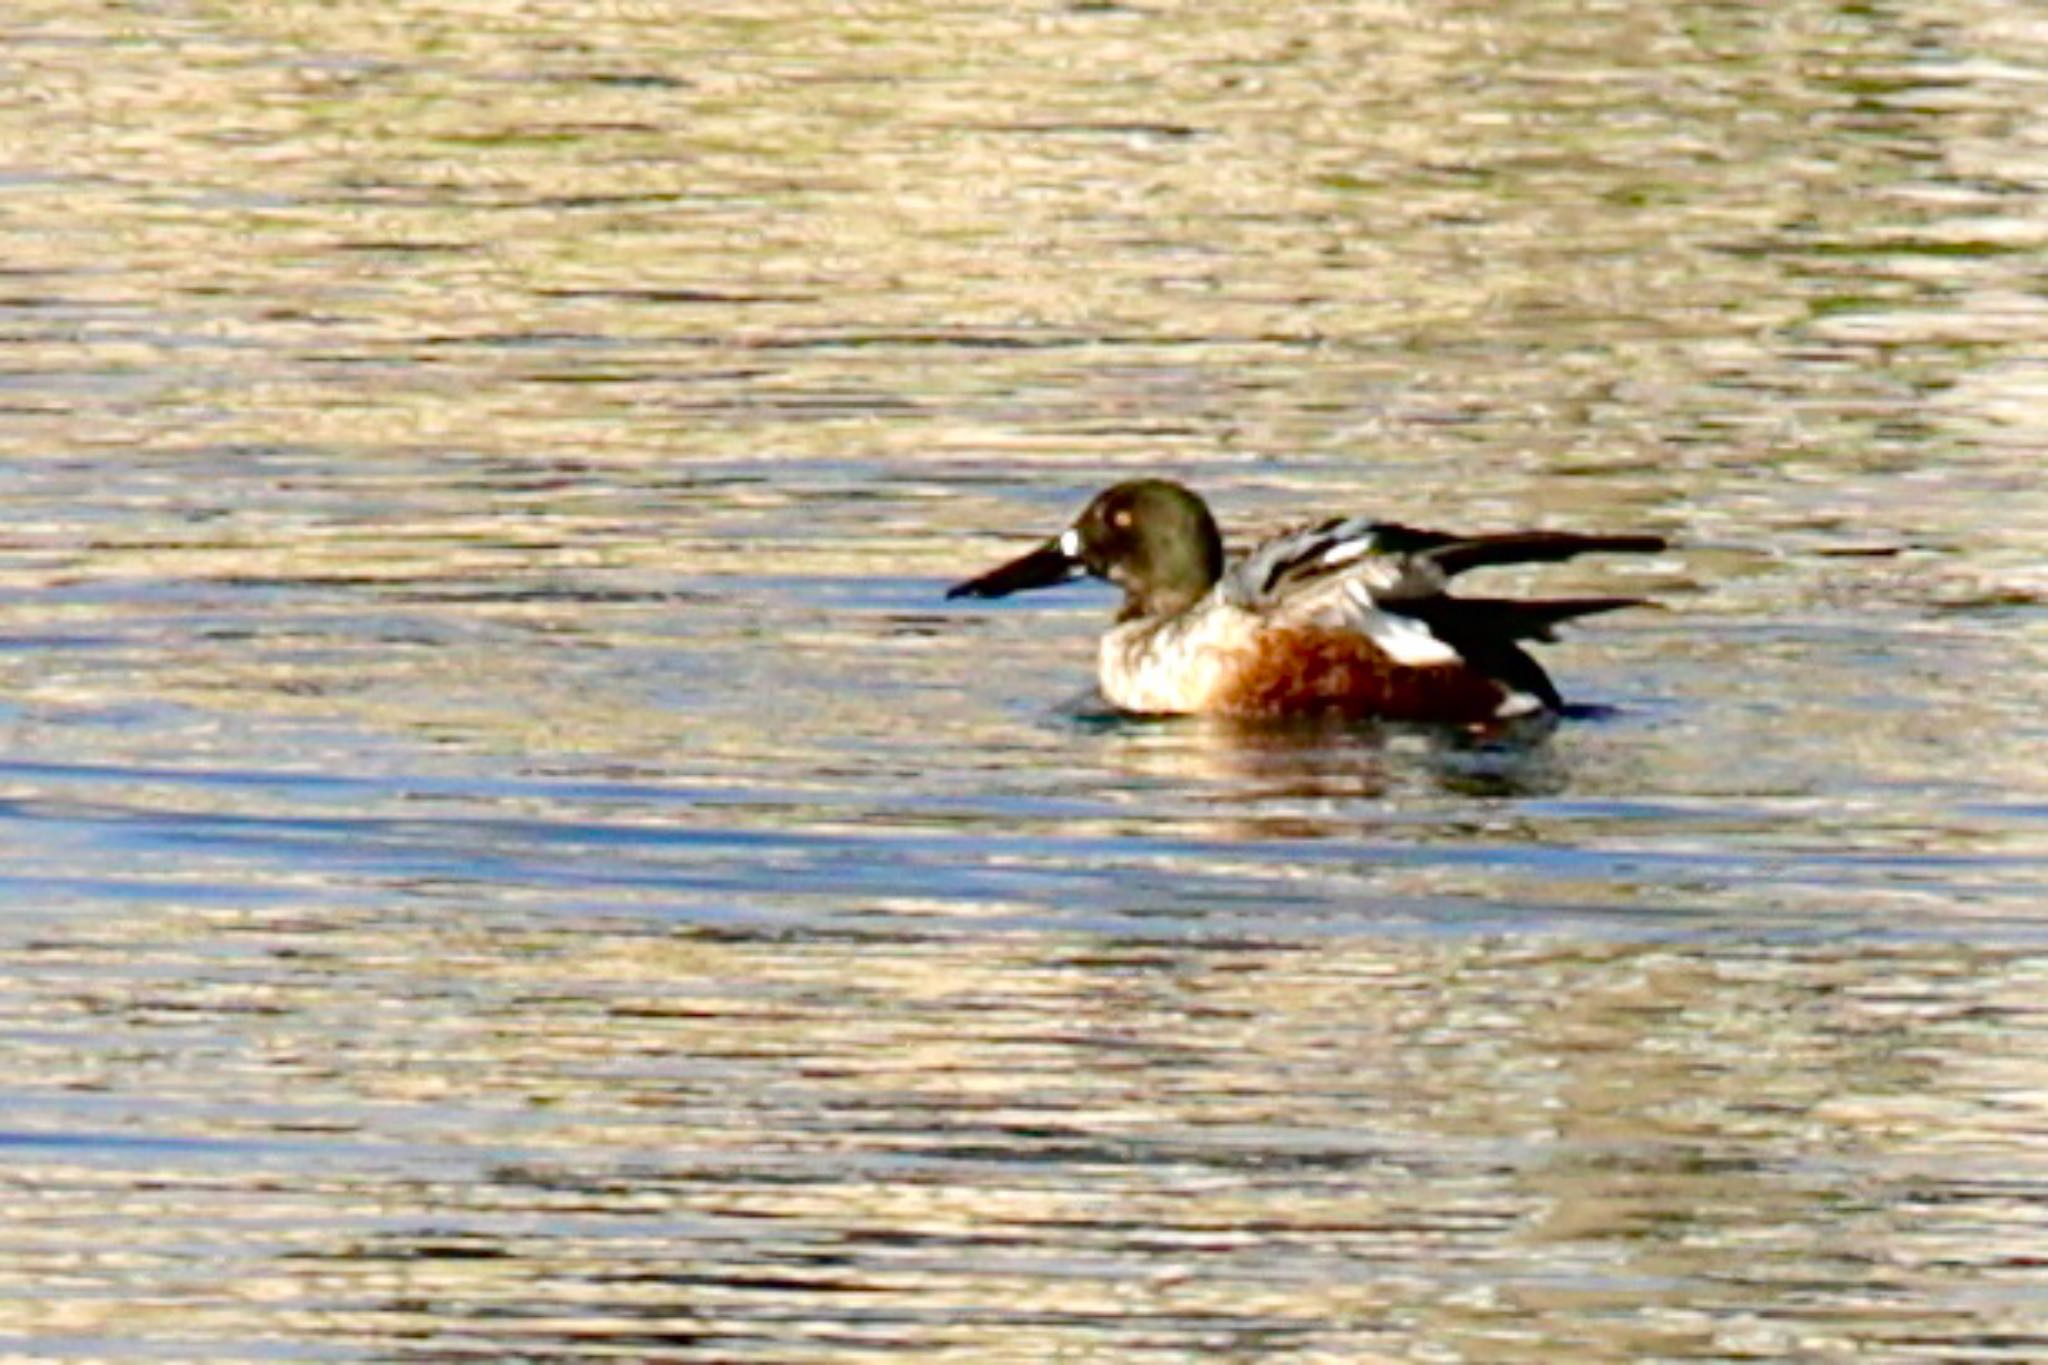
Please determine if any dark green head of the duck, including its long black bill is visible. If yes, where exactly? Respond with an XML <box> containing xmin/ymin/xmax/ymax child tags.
<box><xmin>946</xmin><ymin>479</ymin><xmax>1223</xmax><ymax>620</ymax></box>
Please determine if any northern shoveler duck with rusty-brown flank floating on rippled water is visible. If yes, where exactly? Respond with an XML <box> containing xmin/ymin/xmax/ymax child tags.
<box><xmin>946</xmin><ymin>479</ymin><xmax>1665</xmax><ymax>724</ymax></box>
